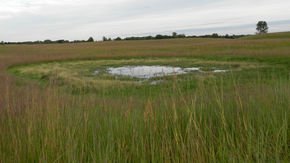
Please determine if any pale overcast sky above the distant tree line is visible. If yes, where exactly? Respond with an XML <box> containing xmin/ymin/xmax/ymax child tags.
<box><xmin>0</xmin><ymin>0</ymin><xmax>290</xmax><ymax>41</ymax></box>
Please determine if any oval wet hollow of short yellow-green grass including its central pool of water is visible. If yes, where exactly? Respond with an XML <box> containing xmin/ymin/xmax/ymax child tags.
<box><xmin>10</xmin><ymin>58</ymin><xmax>261</xmax><ymax>87</ymax></box>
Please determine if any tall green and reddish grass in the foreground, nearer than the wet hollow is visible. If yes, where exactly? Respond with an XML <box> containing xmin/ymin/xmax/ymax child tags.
<box><xmin>0</xmin><ymin>72</ymin><xmax>290</xmax><ymax>162</ymax></box>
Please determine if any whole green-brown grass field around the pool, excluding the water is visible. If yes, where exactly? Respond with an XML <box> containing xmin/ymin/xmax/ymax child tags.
<box><xmin>0</xmin><ymin>32</ymin><xmax>290</xmax><ymax>162</ymax></box>
